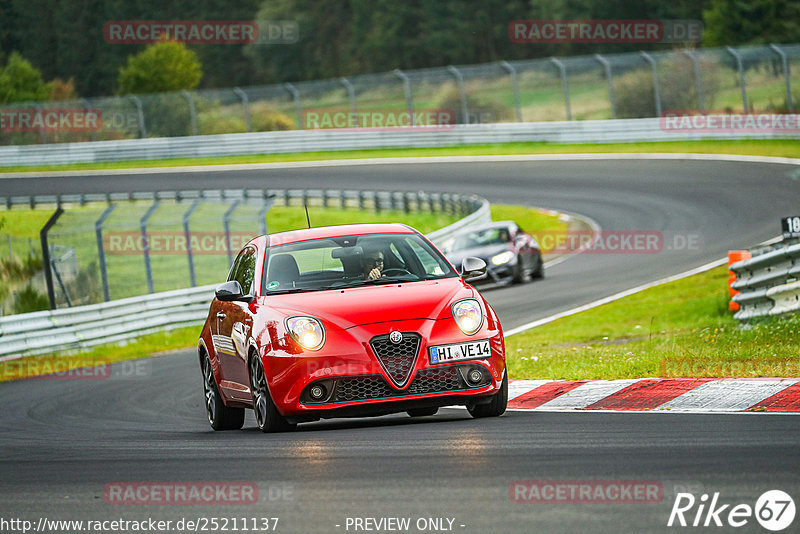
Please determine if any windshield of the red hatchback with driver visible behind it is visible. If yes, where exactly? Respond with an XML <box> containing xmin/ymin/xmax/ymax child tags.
<box><xmin>263</xmin><ymin>233</ymin><xmax>458</xmax><ymax>294</ymax></box>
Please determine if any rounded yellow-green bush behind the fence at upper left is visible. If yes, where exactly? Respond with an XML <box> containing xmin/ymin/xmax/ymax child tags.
<box><xmin>117</xmin><ymin>41</ymin><xmax>203</xmax><ymax>95</ymax></box>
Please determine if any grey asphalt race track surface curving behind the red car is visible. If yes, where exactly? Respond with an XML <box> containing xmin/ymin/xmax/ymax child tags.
<box><xmin>0</xmin><ymin>160</ymin><xmax>800</xmax><ymax>532</ymax></box>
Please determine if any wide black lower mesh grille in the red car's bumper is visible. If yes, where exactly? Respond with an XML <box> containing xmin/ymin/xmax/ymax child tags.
<box><xmin>303</xmin><ymin>364</ymin><xmax>484</xmax><ymax>404</ymax></box>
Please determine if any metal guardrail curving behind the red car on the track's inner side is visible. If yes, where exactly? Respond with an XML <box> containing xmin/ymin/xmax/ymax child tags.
<box><xmin>0</xmin><ymin>191</ymin><xmax>491</xmax><ymax>362</ymax></box>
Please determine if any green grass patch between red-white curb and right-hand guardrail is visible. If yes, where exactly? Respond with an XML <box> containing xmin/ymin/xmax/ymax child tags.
<box><xmin>506</xmin><ymin>266</ymin><xmax>800</xmax><ymax>380</ymax></box>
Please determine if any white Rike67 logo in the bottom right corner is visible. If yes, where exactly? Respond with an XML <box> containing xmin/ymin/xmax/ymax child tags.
<box><xmin>667</xmin><ymin>490</ymin><xmax>795</xmax><ymax>532</ymax></box>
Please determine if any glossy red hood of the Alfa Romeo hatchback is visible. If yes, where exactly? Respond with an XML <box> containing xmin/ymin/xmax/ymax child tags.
<box><xmin>263</xmin><ymin>278</ymin><xmax>474</xmax><ymax>329</ymax></box>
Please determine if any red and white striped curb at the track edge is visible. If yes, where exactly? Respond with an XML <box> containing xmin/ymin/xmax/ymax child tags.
<box><xmin>508</xmin><ymin>378</ymin><xmax>800</xmax><ymax>413</ymax></box>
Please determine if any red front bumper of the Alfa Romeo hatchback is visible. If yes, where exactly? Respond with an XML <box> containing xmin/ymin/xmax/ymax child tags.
<box><xmin>264</xmin><ymin>319</ymin><xmax>505</xmax><ymax>421</ymax></box>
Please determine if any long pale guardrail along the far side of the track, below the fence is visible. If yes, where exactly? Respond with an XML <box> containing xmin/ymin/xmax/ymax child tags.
<box><xmin>0</xmin><ymin>118</ymin><xmax>798</xmax><ymax>166</ymax></box>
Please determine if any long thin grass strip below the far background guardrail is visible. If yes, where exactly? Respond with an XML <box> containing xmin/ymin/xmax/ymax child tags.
<box><xmin>0</xmin><ymin>139</ymin><xmax>800</xmax><ymax>174</ymax></box>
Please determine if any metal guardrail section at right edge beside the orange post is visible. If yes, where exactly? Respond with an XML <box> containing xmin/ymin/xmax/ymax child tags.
<box><xmin>730</xmin><ymin>243</ymin><xmax>800</xmax><ymax>321</ymax></box>
